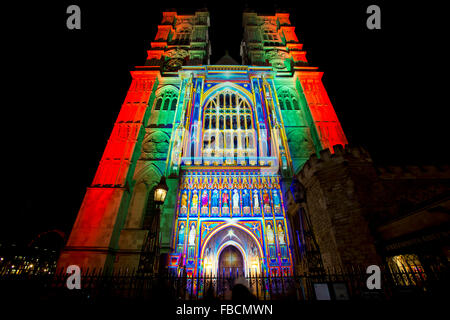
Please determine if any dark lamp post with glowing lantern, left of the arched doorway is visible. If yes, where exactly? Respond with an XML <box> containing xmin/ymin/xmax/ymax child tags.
<box><xmin>139</xmin><ymin>176</ymin><xmax>169</xmax><ymax>274</ymax></box>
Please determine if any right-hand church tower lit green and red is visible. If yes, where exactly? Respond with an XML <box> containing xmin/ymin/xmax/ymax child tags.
<box><xmin>241</xmin><ymin>12</ymin><xmax>347</xmax><ymax>172</ymax></box>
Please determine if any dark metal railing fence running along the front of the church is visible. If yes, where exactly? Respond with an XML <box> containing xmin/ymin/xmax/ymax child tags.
<box><xmin>0</xmin><ymin>267</ymin><xmax>449</xmax><ymax>301</ymax></box>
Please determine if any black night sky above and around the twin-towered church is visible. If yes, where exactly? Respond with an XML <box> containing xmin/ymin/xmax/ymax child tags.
<box><xmin>0</xmin><ymin>0</ymin><xmax>450</xmax><ymax>243</ymax></box>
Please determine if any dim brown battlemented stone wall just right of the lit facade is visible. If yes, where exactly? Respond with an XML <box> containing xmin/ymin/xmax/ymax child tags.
<box><xmin>299</xmin><ymin>146</ymin><xmax>381</xmax><ymax>268</ymax></box>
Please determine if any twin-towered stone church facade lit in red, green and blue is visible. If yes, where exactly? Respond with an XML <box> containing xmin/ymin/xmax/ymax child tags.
<box><xmin>58</xmin><ymin>11</ymin><xmax>347</xmax><ymax>276</ymax></box>
